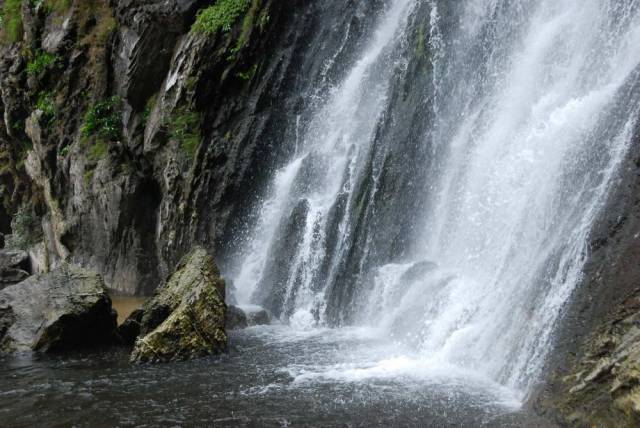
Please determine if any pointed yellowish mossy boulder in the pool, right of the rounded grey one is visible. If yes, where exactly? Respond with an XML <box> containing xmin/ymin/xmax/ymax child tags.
<box><xmin>131</xmin><ymin>248</ymin><xmax>227</xmax><ymax>362</ymax></box>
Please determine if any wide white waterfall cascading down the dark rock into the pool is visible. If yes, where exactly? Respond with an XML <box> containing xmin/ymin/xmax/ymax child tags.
<box><xmin>233</xmin><ymin>0</ymin><xmax>640</xmax><ymax>394</ymax></box>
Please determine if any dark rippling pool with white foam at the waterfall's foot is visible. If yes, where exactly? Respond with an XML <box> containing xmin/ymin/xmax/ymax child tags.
<box><xmin>0</xmin><ymin>327</ymin><xmax>551</xmax><ymax>427</ymax></box>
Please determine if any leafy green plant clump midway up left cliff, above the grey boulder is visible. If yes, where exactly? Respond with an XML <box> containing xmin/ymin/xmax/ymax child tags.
<box><xmin>80</xmin><ymin>96</ymin><xmax>122</xmax><ymax>141</ymax></box>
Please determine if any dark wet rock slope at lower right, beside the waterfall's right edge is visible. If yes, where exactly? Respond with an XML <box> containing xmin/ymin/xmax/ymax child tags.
<box><xmin>533</xmin><ymin>108</ymin><xmax>640</xmax><ymax>427</ymax></box>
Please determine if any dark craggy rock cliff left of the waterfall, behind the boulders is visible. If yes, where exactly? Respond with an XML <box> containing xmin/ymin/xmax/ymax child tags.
<box><xmin>0</xmin><ymin>0</ymin><xmax>382</xmax><ymax>294</ymax></box>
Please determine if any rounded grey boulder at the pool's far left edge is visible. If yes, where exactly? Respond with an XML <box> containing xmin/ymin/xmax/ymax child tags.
<box><xmin>0</xmin><ymin>265</ymin><xmax>117</xmax><ymax>353</ymax></box>
